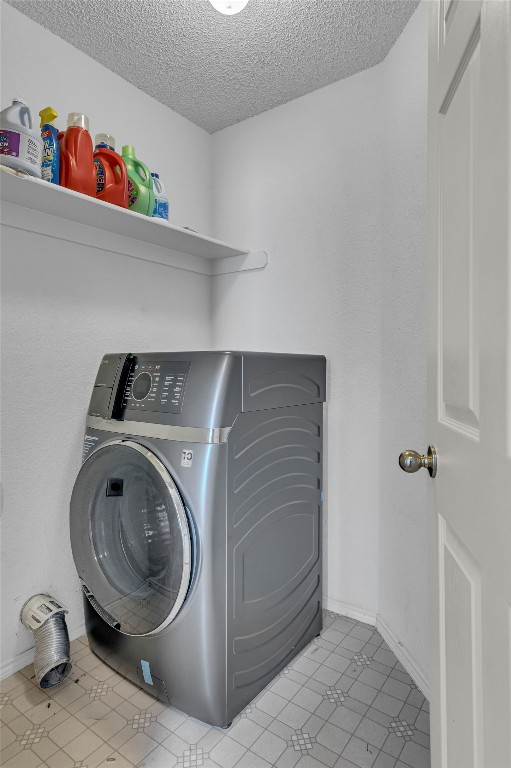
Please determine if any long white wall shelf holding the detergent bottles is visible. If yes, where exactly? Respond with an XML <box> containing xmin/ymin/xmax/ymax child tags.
<box><xmin>0</xmin><ymin>173</ymin><xmax>268</xmax><ymax>275</ymax></box>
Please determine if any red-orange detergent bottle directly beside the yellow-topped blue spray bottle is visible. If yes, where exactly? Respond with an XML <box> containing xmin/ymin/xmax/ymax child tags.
<box><xmin>59</xmin><ymin>112</ymin><xmax>96</xmax><ymax>197</ymax></box>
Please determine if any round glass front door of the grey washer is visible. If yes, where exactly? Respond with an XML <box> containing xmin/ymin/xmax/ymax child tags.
<box><xmin>70</xmin><ymin>440</ymin><xmax>192</xmax><ymax>635</ymax></box>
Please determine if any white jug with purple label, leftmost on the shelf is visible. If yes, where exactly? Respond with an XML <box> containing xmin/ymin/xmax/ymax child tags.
<box><xmin>0</xmin><ymin>99</ymin><xmax>43</xmax><ymax>179</ymax></box>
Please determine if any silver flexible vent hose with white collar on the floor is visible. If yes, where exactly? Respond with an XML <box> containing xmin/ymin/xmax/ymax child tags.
<box><xmin>21</xmin><ymin>595</ymin><xmax>72</xmax><ymax>688</ymax></box>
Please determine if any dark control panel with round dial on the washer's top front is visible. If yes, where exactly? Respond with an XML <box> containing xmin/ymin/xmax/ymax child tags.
<box><xmin>123</xmin><ymin>361</ymin><xmax>190</xmax><ymax>413</ymax></box>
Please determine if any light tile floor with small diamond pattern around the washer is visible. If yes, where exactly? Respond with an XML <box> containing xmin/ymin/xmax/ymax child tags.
<box><xmin>0</xmin><ymin>611</ymin><xmax>430</xmax><ymax>768</ymax></box>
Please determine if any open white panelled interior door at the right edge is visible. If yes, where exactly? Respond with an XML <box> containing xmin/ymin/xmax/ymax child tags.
<box><xmin>429</xmin><ymin>0</ymin><xmax>511</xmax><ymax>768</ymax></box>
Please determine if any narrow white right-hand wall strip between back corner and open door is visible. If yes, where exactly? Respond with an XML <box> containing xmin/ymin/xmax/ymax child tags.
<box><xmin>378</xmin><ymin>2</ymin><xmax>431</xmax><ymax>679</ymax></box>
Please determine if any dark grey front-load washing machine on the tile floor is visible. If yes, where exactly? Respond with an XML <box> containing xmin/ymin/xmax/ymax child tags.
<box><xmin>70</xmin><ymin>352</ymin><xmax>325</xmax><ymax>726</ymax></box>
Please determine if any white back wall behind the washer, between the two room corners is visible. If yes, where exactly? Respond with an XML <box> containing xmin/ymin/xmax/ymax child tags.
<box><xmin>213</xmin><ymin>67</ymin><xmax>385</xmax><ymax>617</ymax></box>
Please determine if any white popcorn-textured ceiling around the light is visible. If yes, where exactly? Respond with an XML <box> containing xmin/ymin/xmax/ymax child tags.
<box><xmin>7</xmin><ymin>0</ymin><xmax>419</xmax><ymax>133</ymax></box>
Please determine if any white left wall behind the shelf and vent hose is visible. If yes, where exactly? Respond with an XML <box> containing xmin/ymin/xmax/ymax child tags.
<box><xmin>0</xmin><ymin>4</ymin><xmax>212</xmax><ymax>676</ymax></box>
